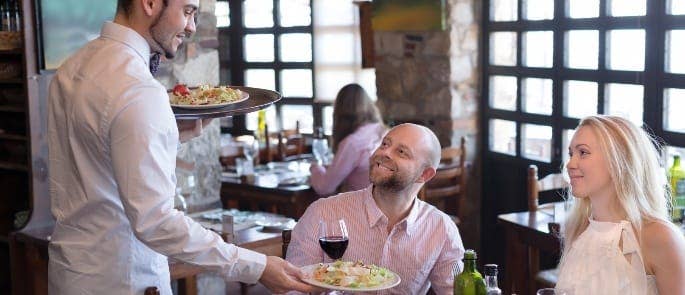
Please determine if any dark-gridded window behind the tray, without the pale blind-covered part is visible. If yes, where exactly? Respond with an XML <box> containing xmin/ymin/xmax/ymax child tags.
<box><xmin>215</xmin><ymin>0</ymin><xmax>315</xmax><ymax>133</ymax></box>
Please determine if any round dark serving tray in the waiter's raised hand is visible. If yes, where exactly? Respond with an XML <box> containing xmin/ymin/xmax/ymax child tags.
<box><xmin>171</xmin><ymin>86</ymin><xmax>281</xmax><ymax>120</ymax></box>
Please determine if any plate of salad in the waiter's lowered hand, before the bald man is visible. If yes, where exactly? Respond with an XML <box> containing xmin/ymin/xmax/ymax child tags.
<box><xmin>302</xmin><ymin>260</ymin><xmax>402</xmax><ymax>292</ymax></box>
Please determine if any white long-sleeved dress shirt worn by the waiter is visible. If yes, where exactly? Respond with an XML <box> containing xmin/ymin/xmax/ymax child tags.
<box><xmin>48</xmin><ymin>22</ymin><xmax>266</xmax><ymax>295</ymax></box>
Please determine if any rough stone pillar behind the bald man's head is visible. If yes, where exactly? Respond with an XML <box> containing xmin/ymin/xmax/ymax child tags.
<box><xmin>374</xmin><ymin>0</ymin><xmax>481</xmax><ymax>248</ymax></box>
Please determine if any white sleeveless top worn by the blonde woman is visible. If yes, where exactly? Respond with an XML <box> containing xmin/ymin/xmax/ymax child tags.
<box><xmin>556</xmin><ymin>218</ymin><xmax>658</xmax><ymax>295</ymax></box>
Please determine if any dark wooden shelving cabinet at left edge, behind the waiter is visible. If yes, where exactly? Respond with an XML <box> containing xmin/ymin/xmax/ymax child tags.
<box><xmin>0</xmin><ymin>0</ymin><xmax>51</xmax><ymax>294</ymax></box>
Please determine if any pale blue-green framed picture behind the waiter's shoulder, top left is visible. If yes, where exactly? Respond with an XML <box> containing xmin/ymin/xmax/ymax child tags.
<box><xmin>35</xmin><ymin>0</ymin><xmax>117</xmax><ymax>70</ymax></box>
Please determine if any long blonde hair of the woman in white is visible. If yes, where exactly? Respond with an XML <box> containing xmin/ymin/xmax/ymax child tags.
<box><xmin>562</xmin><ymin>115</ymin><xmax>671</xmax><ymax>261</ymax></box>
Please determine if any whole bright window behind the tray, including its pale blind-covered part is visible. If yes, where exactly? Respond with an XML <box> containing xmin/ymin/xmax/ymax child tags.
<box><xmin>215</xmin><ymin>0</ymin><xmax>376</xmax><ymax>134</ymax></box>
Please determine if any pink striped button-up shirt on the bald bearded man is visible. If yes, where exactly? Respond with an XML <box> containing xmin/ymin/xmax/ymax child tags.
<box><xmin>287</xmin><ymin>186</ymin><xmax>464</xmax><ymax>294</ymax></box>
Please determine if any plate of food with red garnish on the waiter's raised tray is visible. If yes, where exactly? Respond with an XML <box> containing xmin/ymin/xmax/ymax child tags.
<box><xmin>169</xmin><ymin>84</ymin><xmax>250</xmax><ymax>109</ymax></box>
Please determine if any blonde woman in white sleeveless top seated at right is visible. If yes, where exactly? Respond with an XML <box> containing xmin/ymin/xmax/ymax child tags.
<box><xmin>556</xmin><ymin>116</ymin><xmax>685</xmax><ymax>295</ymax></box>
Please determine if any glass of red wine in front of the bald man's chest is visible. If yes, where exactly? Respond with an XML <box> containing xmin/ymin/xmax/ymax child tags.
<box><xmin>319</xmin><ymin>219</ymin><xmax>349</xmax><ymax>262</ymax></box>
